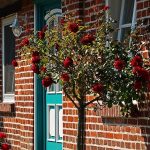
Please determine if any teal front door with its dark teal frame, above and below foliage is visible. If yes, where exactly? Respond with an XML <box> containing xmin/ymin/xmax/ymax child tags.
<box><xmin>36</xmin><ymin>0</ymin><xmax>63</xmax><ymax>150</ymax></box>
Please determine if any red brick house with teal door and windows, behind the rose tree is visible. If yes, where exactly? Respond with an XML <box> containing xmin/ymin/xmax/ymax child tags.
<box><xmin>0</xmin><ymin>0</ymin><xmax>150</xmax><ymax>150</ymax></box>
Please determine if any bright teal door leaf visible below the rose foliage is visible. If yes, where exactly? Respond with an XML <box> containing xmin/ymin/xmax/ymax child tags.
<box><xmin>46</xmin><ymin>84</ymin><xmax>63</xmax><ymax>150</ymax></box>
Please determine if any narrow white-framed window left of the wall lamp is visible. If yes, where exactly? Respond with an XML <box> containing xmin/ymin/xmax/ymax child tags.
<box><xmin>2</xmin><ymin>16</ymin><xmax>15</xmax><ymax>102</ymax></box>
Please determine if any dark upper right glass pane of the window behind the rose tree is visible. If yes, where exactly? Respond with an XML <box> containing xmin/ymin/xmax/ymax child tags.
<box><xmin>122</xmin><ymin>0</ymin><xmax>134</xmax><ymax>24</ymax></box>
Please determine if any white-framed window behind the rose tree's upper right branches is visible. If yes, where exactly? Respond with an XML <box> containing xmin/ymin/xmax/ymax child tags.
<box><xmin>106</xmin><ymin>0</ymin><xmax>136</xmax><ymax>41</ymax></box>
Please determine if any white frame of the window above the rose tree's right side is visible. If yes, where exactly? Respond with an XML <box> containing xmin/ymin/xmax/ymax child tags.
<box><xmin>105</xmin><ymin>0</ymin><xmax>137</xmax><ymax>41</ymax></box>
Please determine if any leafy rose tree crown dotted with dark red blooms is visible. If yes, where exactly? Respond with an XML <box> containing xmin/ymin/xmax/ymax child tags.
<box><xmin>21</xmin><ymin>7</ymin><xmax>150</xmax><ymax>115</ymax></box>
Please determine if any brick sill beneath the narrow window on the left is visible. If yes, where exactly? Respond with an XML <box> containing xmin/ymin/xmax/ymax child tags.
<box><xmin>0</xmin><ymin>102</ymin><xmax>15</xmax><ymax>112</ymax></box>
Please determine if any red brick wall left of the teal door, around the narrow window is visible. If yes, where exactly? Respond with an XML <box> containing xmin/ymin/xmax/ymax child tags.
<box><xmin>0</xmin><ymin>0</ymin><xmax>34</xmax><ymax>150</ymax></box>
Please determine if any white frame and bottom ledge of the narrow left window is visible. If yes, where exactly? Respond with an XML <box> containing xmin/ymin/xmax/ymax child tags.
<box><xmin>2</xmin><ymin>15</ymin><xmax>15</xmax><ymax>103</ymax></box>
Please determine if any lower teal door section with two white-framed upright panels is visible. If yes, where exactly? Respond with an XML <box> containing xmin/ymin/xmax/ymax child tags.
<box><xmin>46</xmin><ymin>104</ymin><xmax>62</xmax><ymax>150</ymax></box>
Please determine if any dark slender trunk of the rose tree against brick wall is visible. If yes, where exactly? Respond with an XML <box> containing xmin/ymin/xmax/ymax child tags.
<box><xmin>77</xmin><ymin>107</ymin><xmax>86</xmax><ymax>150</ymax></box>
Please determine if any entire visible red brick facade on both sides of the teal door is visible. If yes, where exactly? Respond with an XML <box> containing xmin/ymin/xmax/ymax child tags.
<box><xmin>0</xmin><ymin>0</ymin><xmax>150</xmax><ymax>150</ymax></box>
